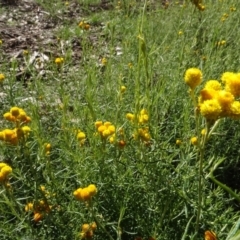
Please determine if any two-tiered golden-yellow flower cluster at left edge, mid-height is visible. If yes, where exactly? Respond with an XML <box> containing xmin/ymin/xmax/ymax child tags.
<box><xmin>0</xmin><ymin>107</ymin><xmax>31</xmax><ymax>145</ymax></box>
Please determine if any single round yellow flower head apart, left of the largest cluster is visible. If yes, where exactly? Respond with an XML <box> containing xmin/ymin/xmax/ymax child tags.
<box><xmin>184</xmin><ymin>68</ymin><xmax>202</xmax><ymax>90</ymax></box>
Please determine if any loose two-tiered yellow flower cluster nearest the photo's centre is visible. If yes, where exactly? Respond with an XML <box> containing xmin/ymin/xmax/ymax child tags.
<box><xmin>126</xmin><ymin>109</ymin><xmax>151</xmax><ymax>143</ymax></box>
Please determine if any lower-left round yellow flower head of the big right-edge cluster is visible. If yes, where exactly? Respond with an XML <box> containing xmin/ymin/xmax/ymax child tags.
<box><xmin>200</xmin><ymin>99</ymin><xmax>222</xmax><ymax>120</ymax></box>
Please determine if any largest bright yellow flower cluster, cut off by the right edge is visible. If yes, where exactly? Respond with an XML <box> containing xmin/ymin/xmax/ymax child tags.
<box><xmin>198</xmin><ymin>72</ymin><xmax>240</xmax><ymax>120</ymax></box>
